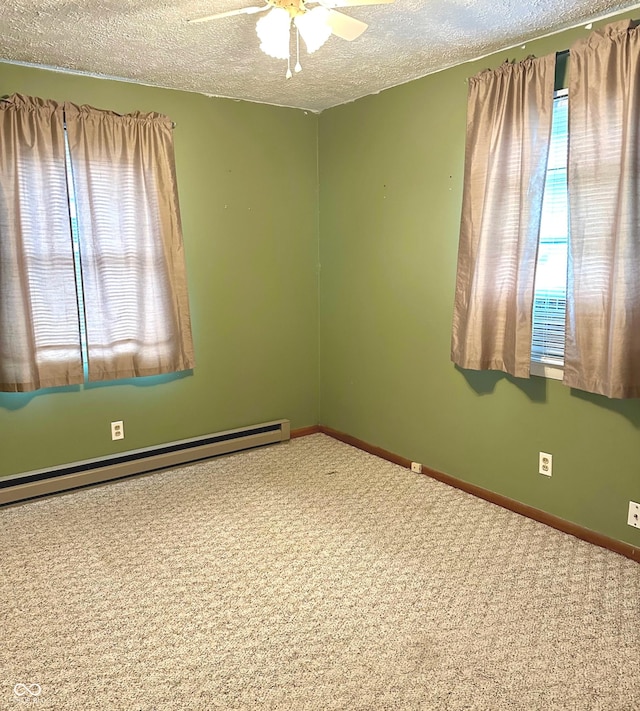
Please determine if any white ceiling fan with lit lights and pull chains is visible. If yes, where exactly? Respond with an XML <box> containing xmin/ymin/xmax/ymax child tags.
<box><xmin>187</xmin><ymin>0</ymin><xmax>394</xmax><ymax>79</ymax></box>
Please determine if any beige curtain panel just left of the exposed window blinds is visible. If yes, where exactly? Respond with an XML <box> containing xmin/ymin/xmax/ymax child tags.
<box><xmin>451</xmin><ymin>55</ymin><xmax>555</xmax><ymax>377</ymax></box>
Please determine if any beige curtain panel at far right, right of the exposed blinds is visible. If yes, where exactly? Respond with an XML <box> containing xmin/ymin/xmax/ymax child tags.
<box><xmin>564</xmin><ymin>21</ymin><xmax>640</xmax><ymax>398</ymax></box>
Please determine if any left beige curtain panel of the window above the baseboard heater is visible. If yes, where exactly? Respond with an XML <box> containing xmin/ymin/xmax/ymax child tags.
<box><xmin>0</xmin><ymin>94</ymin><xmax>83</xmax><ymax>392</ymax></box>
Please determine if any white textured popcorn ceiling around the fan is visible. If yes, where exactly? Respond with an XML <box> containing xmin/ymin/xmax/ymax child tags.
<box><xmin>0</xmin><ymin>0</ymin><xmax>638</xmax><ymax>111</ymax></box>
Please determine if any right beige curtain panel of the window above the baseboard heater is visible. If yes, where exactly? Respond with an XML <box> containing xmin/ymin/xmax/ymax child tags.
<box><xmin>65</xmin><ymin>104</ymin><xmax>194</xmax><ymax>380</ymax></box>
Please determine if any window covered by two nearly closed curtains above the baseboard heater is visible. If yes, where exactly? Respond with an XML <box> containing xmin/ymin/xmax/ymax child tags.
<box><xmin>0</xmin><ymin>95</ymin><xmax>193</xmax><ymax>392</ymax></box>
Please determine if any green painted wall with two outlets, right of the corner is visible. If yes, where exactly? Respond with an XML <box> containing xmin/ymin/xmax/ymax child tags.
<box><xmin>319</xmin><ymin>13</ymin><xmax>640</xmax><ymax>546</ymax></box>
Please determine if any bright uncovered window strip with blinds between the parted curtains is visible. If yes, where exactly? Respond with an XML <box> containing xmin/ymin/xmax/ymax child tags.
<box><xmin>531</xmin><ymin>90</ymin><xmax>569</xmax><ymax>380</ymax></box>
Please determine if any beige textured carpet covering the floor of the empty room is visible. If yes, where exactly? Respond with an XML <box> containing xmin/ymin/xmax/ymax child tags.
<box><xmin>0</xmin><ymin>435</ymin><xmax>640</xmax><ymax>711</ymax></box>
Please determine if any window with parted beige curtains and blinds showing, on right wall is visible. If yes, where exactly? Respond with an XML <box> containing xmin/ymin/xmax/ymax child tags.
<box><xmin>451</xmin><ymin>20</ymin><xmax>640</xmax><ymax>398</ymax></box>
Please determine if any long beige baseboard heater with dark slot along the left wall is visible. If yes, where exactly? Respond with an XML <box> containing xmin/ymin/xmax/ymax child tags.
<box><xmin>0</xmin><ymin>420</ymin><xmax>290</xmax><ymax>504</ymax></box>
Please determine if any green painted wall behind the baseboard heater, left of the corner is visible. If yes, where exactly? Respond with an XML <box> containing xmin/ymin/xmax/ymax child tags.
<box><xmin>0</xmin><ymin>64</ymin><xmax>318</xmax><ymax>476</ymax></box>
